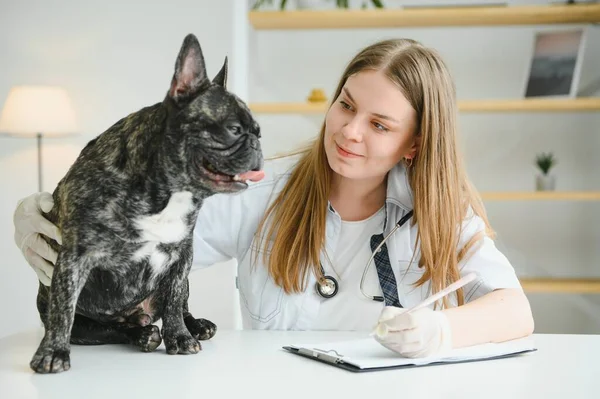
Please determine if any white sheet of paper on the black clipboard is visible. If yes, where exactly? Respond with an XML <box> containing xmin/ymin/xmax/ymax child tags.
<box><xmin>291</xmin><ymin>337</ymin><xmax>535</xmax><ymax>368</ymax></box>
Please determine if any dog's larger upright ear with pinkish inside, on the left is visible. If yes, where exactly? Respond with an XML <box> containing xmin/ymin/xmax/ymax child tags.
<box><xmin>169</xmin><ymin>34</ymin><xmax>209</xmax><ymax>102</ymax></box>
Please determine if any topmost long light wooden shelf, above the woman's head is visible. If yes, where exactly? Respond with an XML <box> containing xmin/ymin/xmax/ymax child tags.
<box><xmin>249</xmin><ymin>4</ymin><xmax>600</xmax><ymax>30</ymax></box>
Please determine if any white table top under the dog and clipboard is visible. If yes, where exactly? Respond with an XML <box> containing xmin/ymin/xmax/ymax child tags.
<box><xmin>0</xmin><ymin>330</ymin><xmax>600</xmax><ymax>399</ymax></box>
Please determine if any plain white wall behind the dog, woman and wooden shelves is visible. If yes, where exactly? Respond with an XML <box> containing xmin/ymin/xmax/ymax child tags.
<box><xmin>0</xmin><ymin>0</ymin><xmax>600</xmax><ymax>336</ymax></box>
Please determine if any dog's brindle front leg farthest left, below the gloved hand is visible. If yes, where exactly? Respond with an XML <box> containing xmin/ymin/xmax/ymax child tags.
<box><xmin>29</xmin><ymin>252</ymin><xmax>90</xmax><ymax>374</ymax></box>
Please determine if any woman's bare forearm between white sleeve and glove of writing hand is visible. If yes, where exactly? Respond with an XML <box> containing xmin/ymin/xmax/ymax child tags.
<box><xmin>443</xmin><ymin>288</ymin><xmax>534</xmax><ymax>348</ymax></box>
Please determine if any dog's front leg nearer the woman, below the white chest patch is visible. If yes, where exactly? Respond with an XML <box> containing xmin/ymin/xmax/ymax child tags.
<box><xmin>161</xmin><ymin>240</ymin><xmax>200</xmax><ymax>354</ymax></box>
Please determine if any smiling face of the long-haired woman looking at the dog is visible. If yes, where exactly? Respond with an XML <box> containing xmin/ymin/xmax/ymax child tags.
<box><xmin>325</xmin><ymin>70</ymin><xmax>416</xmax><ymax>183</ymax></box>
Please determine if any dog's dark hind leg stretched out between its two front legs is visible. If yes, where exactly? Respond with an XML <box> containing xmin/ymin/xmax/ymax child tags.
<box><xmin>71</xmin><ymin>315</ymin><xmax>162</xmax><ymax>352</ymax></box>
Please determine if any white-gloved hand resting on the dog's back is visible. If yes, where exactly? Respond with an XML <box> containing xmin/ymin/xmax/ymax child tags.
<box><xmin>13</xmin><ymin>192</ymin><xmax>62</xmax><ymax>286</ymax></box>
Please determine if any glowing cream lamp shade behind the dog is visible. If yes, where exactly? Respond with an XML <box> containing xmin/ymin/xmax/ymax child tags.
<box><xmin>0</xmin><ymin>86</ymin><xmax>77</xmax><ymax>136</ymax></box>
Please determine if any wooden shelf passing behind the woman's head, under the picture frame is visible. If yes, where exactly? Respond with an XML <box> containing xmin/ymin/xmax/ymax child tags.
<box><xmin>250</xmin><ymin>97</ymin><xmax>600</xmax><ymax>114</ymax></box>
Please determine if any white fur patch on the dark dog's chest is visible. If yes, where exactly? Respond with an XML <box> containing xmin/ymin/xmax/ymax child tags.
<box><xmin>134</xmin><ymin>191</ymin><xmax>194</xmax><ymax>243</ymax></box>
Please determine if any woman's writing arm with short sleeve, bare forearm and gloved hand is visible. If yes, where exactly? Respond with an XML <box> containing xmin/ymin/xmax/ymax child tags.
<box><xmin>375</xmin><ymin>211</ymin><xmax>534</xmax><ymax>357</ymax></box>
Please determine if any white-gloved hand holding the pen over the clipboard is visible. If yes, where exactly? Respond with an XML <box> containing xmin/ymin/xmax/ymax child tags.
<box><xmin>374</xmin><ymin>306</ymin><xmax>452</xmax><ymax>358</ymax></box>
